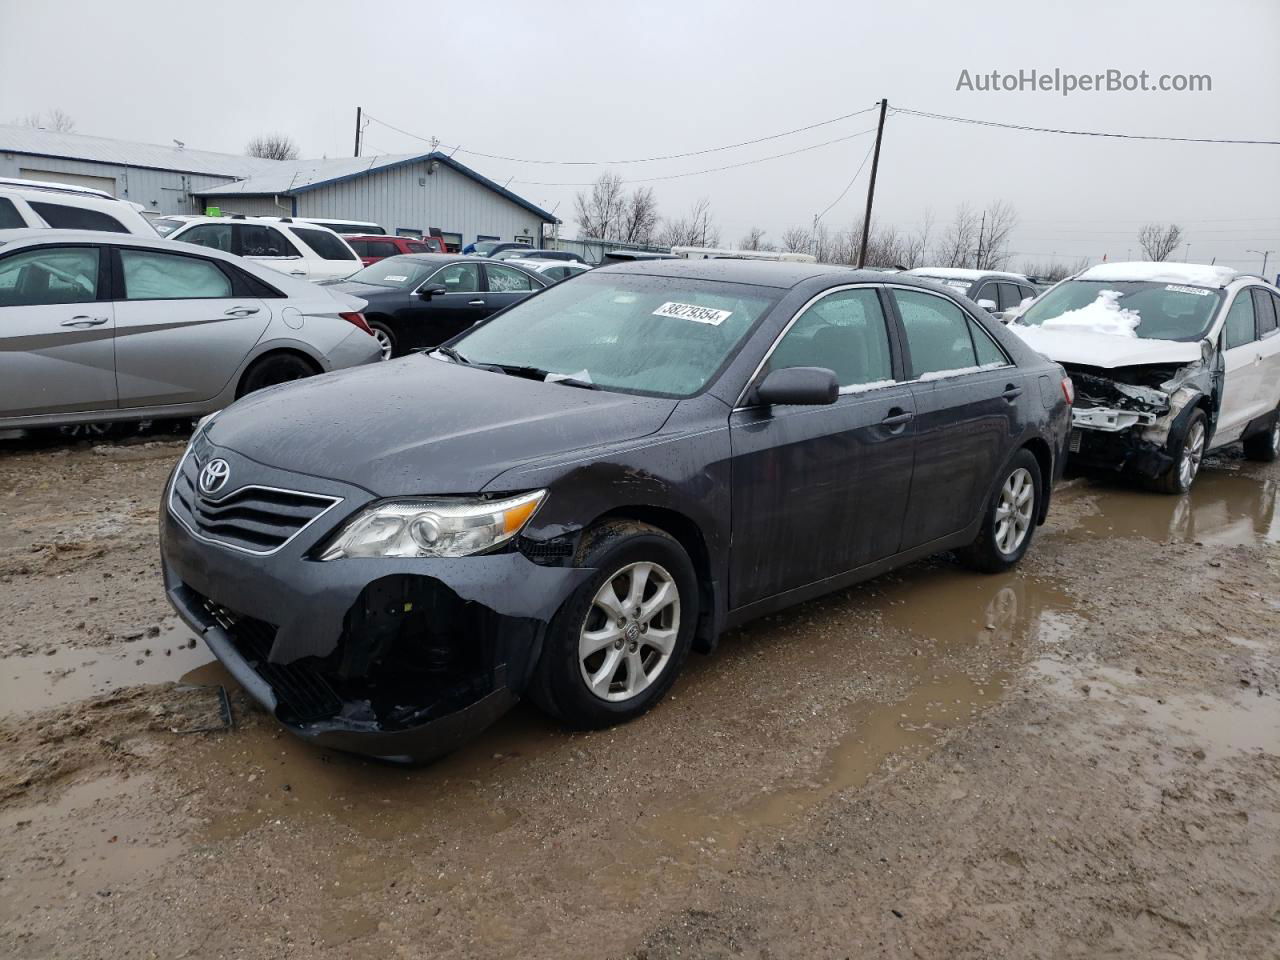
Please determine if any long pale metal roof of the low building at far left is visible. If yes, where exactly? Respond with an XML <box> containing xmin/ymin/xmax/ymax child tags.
<box><xmin>0</xmin><ymin>124</ymin><xmax>280</xmax><ymax>177</ymax></box>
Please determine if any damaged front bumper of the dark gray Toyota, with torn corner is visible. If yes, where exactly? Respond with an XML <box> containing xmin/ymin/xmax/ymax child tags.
<box><xmin>160</xmin><ymin>507</ymin><xmax>593</xmax><ymax>762</ymax></box>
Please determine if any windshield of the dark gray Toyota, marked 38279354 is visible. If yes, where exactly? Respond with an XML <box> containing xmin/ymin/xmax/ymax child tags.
<box><xmin>451</xmin><ymin>274</ymin><xmax>780</xmax><ymax>397</ymax></box>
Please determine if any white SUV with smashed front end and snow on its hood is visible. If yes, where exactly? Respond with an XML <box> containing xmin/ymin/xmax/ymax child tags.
<box><xmin>1009</xmin><ymin>262</ymin><xmax>1280</xmax><ymax>494</ymax></box>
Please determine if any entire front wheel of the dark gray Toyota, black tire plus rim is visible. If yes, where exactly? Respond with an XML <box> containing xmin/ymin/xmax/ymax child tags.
<box><xmin>527</xmin><ymin>521</ymin><xmax>698</xmax><ymax>730</ymax></box>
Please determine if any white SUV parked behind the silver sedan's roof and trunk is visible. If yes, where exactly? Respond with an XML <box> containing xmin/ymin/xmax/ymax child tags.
<box><xmin>168</xmin><ymin>216</ymin><xmax>364</xmax><ymax>283</ymax></box>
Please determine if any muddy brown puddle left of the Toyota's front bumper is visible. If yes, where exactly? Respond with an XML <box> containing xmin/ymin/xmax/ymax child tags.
<box><xmin>0</xmin><ymin>622</ymin><xmax>212</xmax><ymax>713</ymax></box>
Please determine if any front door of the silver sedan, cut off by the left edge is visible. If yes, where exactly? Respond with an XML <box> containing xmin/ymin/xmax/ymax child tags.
<box><xmin>0</xmin><ymin>244</ymin><xmax>116</xmax><ymax>420</ymax></box>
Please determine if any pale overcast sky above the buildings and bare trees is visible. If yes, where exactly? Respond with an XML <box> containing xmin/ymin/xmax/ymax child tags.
<box><xmin>0</xmin><ymin>0</ymin><xmax>1280</xmax><ymax>273</ymax></box>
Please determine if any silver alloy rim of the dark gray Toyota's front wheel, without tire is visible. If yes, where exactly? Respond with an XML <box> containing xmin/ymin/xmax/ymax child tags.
<box><xmin>577</xmin><ymin>562</ymin><xmax>680</xmax><ymax>703</ymax></box>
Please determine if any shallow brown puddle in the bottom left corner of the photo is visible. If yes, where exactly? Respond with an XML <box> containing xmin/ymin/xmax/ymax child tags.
<box><xmin>0</xmin><ymin>777</ymin><xmax>186</xmax><ymax>922</ymax></box>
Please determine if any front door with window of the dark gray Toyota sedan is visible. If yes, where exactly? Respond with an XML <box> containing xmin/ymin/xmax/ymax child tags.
<box><xmin>730</xmin><ymin>287</ymin><xmax>915</xmax><ymax>608</ymax></box>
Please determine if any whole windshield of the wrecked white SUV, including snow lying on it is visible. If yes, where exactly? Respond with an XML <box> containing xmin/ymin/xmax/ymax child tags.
<box><xmin>1018</xmin><ymin>280</ymin><xmax>1221</xmax><ymax>342</ymax></box>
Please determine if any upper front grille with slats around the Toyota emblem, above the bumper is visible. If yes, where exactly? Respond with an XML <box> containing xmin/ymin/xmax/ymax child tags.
<box><xmin>169</xmin><ymin>454</ymin><xmax>339</xmax><ymax>554</ymax></box>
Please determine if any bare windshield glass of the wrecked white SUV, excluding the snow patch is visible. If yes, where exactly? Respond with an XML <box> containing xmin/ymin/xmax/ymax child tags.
<box><xmin>1018</xmin><ymin>280</ymin><xmax>1221</xmax><ymax>340</ymax></box>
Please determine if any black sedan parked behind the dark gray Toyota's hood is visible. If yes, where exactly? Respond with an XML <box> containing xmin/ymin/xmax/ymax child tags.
<box><xmin>330</xmin><ymin>253</ymin><xmax>552</xmax><ymax>360</ymax></box>
